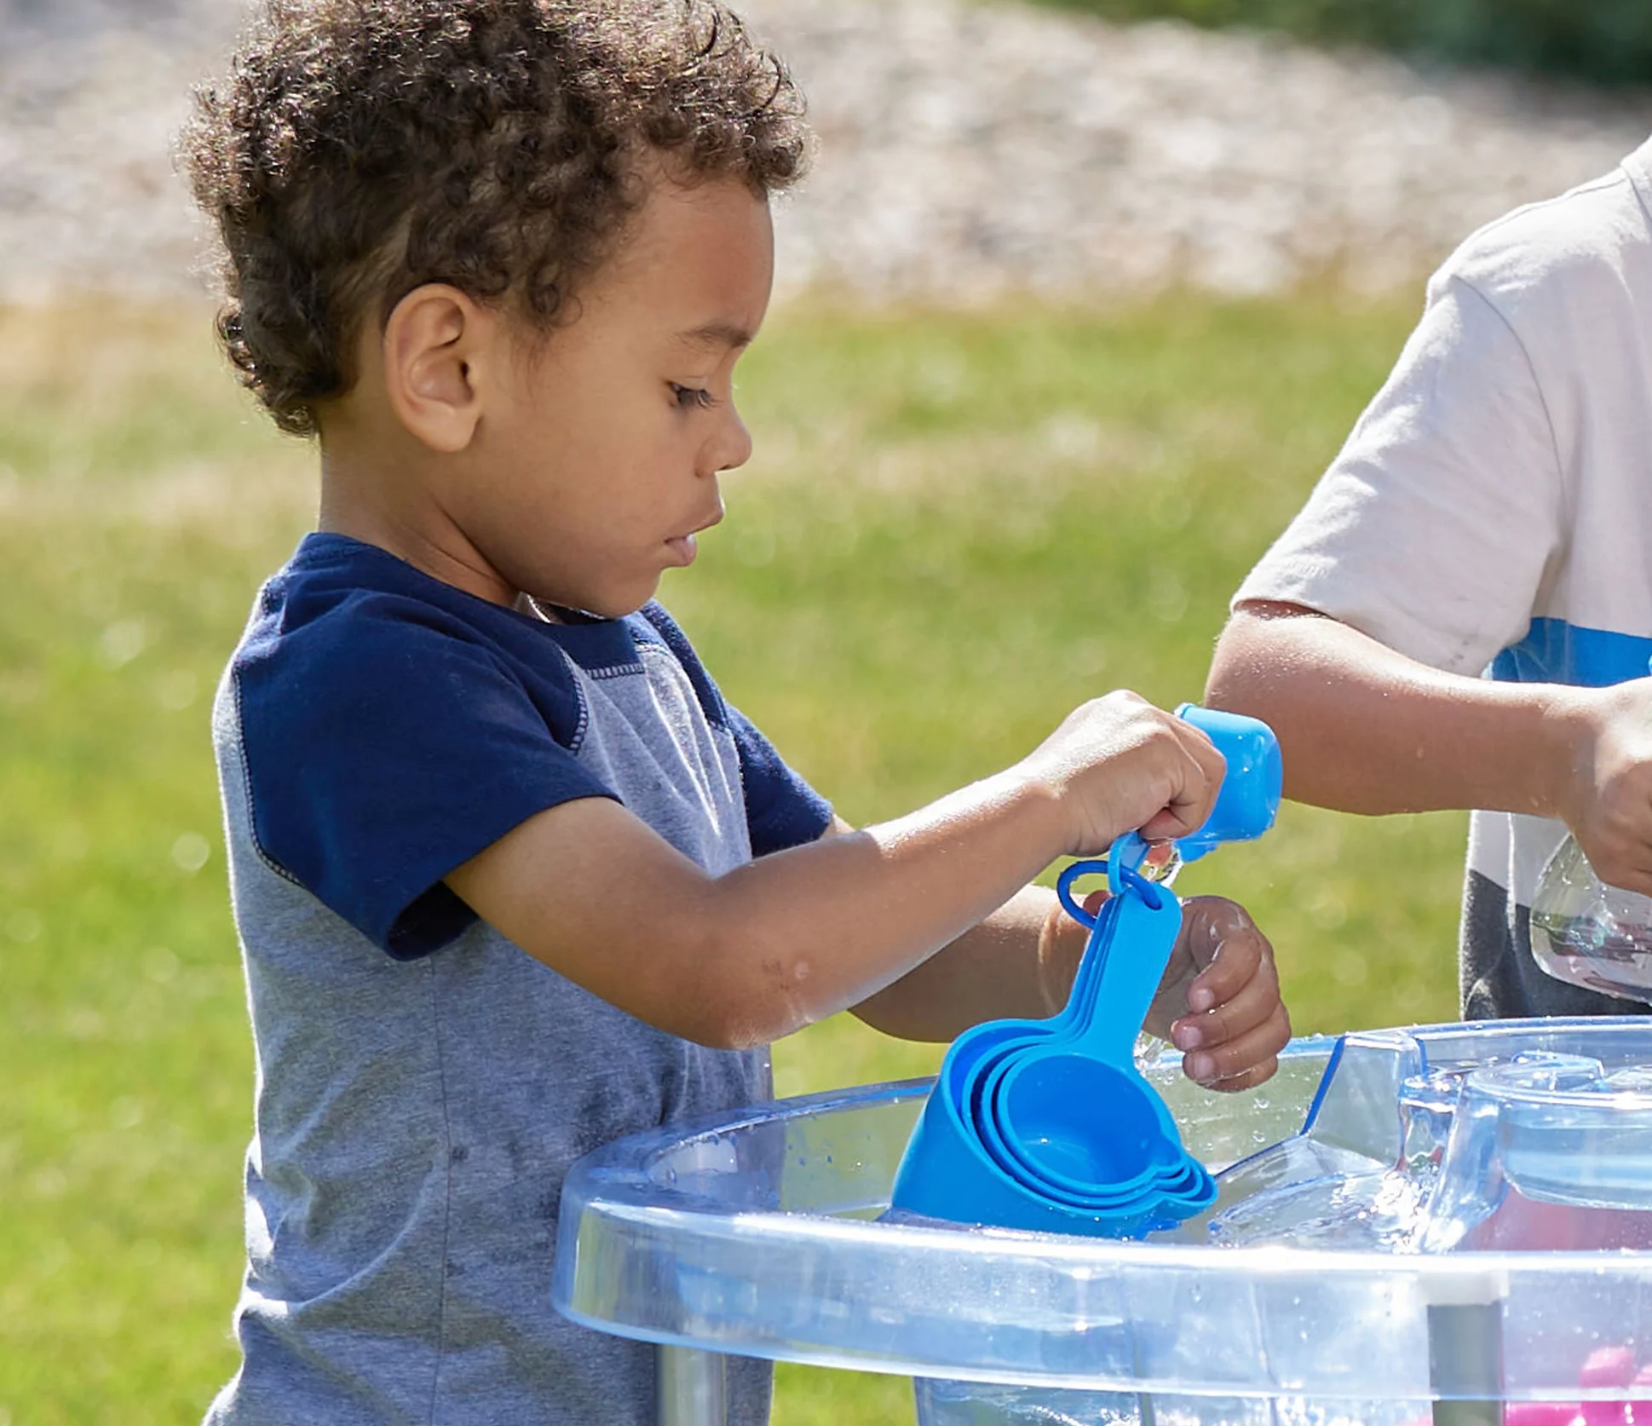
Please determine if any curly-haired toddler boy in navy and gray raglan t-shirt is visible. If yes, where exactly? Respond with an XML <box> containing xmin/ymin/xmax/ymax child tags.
<box><xmin>188</xmin><ymin>0</ymin><xmax>1289</xmax><ymax>1426</ymax></box>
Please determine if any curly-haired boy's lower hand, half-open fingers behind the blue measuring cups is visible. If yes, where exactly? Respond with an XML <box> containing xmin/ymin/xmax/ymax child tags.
<box><xmin>1143</xmin><ymin>896</ymin><xmax>1290</xmax><ymax>1091</ymax></box>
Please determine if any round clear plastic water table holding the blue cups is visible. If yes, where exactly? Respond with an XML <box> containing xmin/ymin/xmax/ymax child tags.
<box><xmin>553</xmin><ymin>1016</ymin><xmax>1652</xmax><ymax>1426</ymax></box>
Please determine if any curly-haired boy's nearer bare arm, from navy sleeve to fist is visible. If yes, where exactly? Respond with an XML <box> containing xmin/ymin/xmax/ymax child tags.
<box><xmin>448</xmin><ymin>694</ymin><xmax>1222</xmax><ymax>1046</ymax></box>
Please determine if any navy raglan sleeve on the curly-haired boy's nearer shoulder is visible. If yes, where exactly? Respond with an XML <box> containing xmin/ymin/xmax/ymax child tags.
<box><xmin>233</xmin><ymin>597</ymin><xmax>613</xmax><ymax>960</ymax></box>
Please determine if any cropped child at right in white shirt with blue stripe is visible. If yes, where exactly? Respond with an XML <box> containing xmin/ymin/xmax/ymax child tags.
<box><xmin>1208</xmin><ymin>144</ymin><xmax>1652</xmax><ymax>1020</ymax></box>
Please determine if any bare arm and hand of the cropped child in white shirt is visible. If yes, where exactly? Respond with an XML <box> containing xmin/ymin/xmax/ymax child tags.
<box><xmin>1206</xmin><ymin>601</ymin><xmax>1652</xmax><ymax>894</ymax></box>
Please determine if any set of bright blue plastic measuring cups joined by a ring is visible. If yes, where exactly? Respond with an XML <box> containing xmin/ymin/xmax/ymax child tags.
<box><xmin>890</xmin><ymin>704</ymin><xmax>1282</xmax><ymax>1238</ymax></box>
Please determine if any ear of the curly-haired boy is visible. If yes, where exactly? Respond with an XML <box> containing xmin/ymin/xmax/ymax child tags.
<box><xmin>383</xmin><ymin>283</ymin><xmax>497</xmax><ymax>454</ymax></box>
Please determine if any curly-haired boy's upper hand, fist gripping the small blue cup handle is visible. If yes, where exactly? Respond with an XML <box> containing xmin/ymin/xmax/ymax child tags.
<box><xmin>1019</xmin><ymin>691</ymin><xmax>1227</xmax><ymax>856</ymax></box>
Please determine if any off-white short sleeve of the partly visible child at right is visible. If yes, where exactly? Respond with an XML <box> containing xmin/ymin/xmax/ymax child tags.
<box><xmin>1234</xmin><ymin>278</ymin><xmax>1566</xmax><ymax>674</ymax></box>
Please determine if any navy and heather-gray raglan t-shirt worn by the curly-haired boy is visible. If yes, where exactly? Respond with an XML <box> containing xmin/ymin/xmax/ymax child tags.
<box><xmin>208</xmin><ymin>535</ymin><xmax>831</xmax><ymax>1426</ymax></box>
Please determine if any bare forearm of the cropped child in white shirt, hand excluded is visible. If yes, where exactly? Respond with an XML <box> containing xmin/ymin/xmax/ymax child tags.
<box><xmin>1206</xmin><ymin>605</ymin><xmax>1583</xmax><ymax>816</ymax></box>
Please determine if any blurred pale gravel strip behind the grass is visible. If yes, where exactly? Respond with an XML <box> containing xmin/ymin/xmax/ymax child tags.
<box><xmin>0</xmin><ymin>0</ymin><xmax>1652</xmax><ymax>302</ymax></box>
